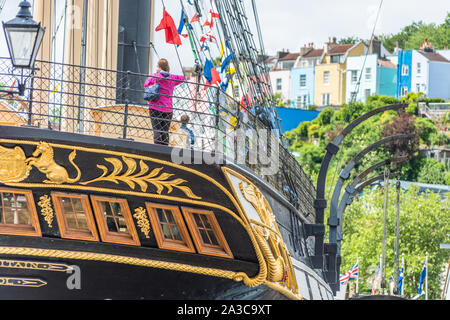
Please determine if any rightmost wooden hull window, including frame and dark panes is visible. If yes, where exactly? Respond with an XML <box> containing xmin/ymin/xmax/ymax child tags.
<box><xmin>181</xmin><ymin>208</ymin><xmax>233</xmax><ymax>258</ymax></box>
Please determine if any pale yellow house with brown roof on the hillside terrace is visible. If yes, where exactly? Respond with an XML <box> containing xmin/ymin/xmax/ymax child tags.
<box><xmin>314</xmin><ymin>38</ymin><xmax>365</xmax><ymax>106</ymax></box>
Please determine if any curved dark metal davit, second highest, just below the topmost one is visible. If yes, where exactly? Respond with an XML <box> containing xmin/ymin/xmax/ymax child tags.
<box><xmin>325</xmin><ymin>134</ymin><xmax>415</xmax><ymax>290</ymax></box>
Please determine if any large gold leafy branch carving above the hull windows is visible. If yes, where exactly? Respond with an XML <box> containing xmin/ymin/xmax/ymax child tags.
<box><xmin>80</xmin><ymin>156</ymin><xmax>201</xmax><ymax>199</ymax></box>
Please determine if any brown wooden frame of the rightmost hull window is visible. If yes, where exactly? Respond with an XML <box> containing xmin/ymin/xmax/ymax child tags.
<box><xmin>181</xmin><ymin>207</ymin><xmax>233</xmax><ymax>259</ymax></box>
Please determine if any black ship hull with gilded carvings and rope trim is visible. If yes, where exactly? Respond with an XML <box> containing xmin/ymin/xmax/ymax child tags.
<box><xmin>0</xmin><ymin>127</ymin><xmax>333</xmax><ymax>300</ymax></box>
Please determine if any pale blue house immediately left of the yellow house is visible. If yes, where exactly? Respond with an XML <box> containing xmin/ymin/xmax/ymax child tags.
<box><xmin>290</xmin><ymin>43</ymin><xmax>323</xmax><ymax>109</ymax></box>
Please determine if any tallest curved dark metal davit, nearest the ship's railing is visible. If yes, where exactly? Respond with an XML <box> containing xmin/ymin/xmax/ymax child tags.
<box><xmin>305</xmin><ymin>104</ymin><xmax>407</xmax><ymax>269</ymax></box>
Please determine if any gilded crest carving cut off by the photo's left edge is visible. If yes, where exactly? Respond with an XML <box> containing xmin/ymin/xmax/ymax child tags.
<box><xmin>0</xmin><ymin>146</ymin><xmax>31</xmax><ymax>183</ymax></box>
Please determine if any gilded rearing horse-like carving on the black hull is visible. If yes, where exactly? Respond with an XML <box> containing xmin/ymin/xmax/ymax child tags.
<box><xmin>26</xmin><ymin>142</ymin><xmax>81</xmax><ymax>184</ymax></box>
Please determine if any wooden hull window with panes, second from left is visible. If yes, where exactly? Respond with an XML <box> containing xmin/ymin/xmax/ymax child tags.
<box><xmin>52</xmin><ymin>192</ymin><xmax>99</xmax><ymax>241</ymax></box>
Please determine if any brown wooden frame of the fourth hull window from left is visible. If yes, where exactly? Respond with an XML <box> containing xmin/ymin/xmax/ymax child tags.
<box><xmin>145</xmin><ymin>202</ymin><xmax>196</xmax><ymax>253</ymax></box>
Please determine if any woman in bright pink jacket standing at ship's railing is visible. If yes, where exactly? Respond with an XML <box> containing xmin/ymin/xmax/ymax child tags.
<box><xmin>144</xmin><ymin>59</ymin><xmax>184</xmax><ymax>146</ymax></box>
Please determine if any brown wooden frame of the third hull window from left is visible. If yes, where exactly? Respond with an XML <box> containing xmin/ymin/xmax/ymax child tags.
<box><xmin>91</xmin><ymin>195</ymin><xmax>141</xmax><ymax>246</ymax></box>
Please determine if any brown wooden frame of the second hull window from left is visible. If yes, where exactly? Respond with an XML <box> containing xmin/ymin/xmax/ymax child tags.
<box><xmin>52</xmin><ymin>192</ymin><xmax>99</xmax><ymax>241</ymax></box>
